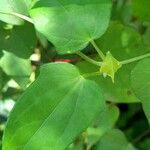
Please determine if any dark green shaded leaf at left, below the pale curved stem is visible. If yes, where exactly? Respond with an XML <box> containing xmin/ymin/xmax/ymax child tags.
<box><xmin>0</xmin><ymin>23</ymin><xmax>37</xmax><ymax>58</ymax></box>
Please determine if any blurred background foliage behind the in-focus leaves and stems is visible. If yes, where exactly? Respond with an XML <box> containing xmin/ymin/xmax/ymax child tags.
<box><xmin>0</xmin><ymin>0</ymin><xmax>150</xmax><ymax>150</ymax></box>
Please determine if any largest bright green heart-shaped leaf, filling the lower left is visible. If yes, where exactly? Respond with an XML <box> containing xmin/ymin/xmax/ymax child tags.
<box><xmin>3</xmin><ymin>63</ymin><xmax>104</xmax><ymax>150</ymax></box>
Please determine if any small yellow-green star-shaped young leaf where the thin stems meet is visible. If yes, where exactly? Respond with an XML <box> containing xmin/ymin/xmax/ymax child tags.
<box><xmin>100</xmin><ymin>51</ymin><xmax>122</xmax><ymax>83</ymax></box>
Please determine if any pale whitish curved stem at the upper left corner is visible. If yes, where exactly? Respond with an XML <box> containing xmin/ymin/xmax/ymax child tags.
<box><xmin>0</xmin><ymin>11</ymin><xmax>33</xmax><ymax>24</ymax></box>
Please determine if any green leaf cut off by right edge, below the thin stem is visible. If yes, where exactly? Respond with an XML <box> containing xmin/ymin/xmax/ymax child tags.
<box><xmin>131</xmin><ymin>59</ymin><xmax>150</xmax><ymax>123</ymax></box>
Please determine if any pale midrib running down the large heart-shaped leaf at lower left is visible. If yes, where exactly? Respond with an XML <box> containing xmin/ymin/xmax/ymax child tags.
<box><xmin>22</xmin><ymin>77</ymin><xmax>83</xmax><ymax>150</ymax></box>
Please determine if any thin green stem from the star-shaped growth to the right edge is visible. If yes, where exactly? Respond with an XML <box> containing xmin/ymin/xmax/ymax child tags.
<box><xmin>120</xmin><ymin>53</ymin><xmax>150</xmax><ymax>65</ymax></box>
